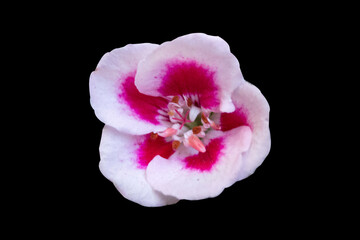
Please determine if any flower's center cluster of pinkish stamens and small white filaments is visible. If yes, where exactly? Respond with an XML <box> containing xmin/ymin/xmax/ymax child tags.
<box><xmin>151</xmin><ymin>96</ymin><xmax>220</xmax><ymax>152</ymax></box>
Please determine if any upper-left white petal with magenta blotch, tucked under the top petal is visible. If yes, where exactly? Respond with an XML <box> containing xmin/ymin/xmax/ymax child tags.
<box><xmin>90</xmin><ymin>43</ymin><xmax>168</xmax><ymax>134</ymax></box>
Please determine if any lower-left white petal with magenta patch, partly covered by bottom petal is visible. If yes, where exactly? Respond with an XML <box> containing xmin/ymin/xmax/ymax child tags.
<box><xmin>99</xmin><ymin>125</ymin><xmax>178</xmax><ymax>207</ymax></box>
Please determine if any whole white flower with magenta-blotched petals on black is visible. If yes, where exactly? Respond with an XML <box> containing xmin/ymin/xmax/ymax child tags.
<box><xmin>90</xmin><ymin>33</ymin><xmax>270</xmax><ymax>206</ymax></box>
